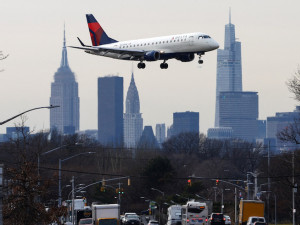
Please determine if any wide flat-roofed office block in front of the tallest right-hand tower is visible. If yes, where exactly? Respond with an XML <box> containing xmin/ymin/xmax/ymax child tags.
<box><xmin>219</xmin><ymin>92</ymin><xmax>258</xmax><ymax>141</ymax></box>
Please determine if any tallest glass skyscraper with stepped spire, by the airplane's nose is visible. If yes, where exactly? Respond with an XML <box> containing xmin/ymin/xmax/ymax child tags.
<box><xmin>215</xmin><ymin>12</ymin><xmax>243</xmax><ymax>127</ymax></box>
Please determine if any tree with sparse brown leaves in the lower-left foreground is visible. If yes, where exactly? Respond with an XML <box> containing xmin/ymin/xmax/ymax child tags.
<box><xmin>3</xmin><ymin>121</ymin><xmax>66</xmax><ymax>225</ymax></box>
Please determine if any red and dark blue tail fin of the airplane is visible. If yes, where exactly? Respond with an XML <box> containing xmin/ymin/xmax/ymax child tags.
<box><xmin>86</xmin><ymin>14</ymin><xmax>118</xmax><ymax>46</ymax></box>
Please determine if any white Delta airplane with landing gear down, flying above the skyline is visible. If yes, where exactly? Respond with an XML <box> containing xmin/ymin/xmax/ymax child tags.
<box><xmin>69</xmin><ymin>14</ymin><xmax>219</xmax><ymax>69</ymax></box>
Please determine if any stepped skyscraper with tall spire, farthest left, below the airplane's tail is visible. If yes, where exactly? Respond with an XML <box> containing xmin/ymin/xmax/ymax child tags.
<box><xmin>50</xmin><ymin>27</ymin><xmax>79</xmax><ymax>134</ymax></box>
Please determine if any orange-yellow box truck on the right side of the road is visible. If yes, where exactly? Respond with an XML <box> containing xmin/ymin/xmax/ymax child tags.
<box><xmin>239</xmin><ymin>200</ymin><xmax>265</xmax><ymax>225</ymax></box>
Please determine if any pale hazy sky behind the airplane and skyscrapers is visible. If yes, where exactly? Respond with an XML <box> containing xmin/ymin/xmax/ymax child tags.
<box><xmin>0</xmin><ymin>0</ymin><xmax>300</xmax><ymax>133</ymax></box>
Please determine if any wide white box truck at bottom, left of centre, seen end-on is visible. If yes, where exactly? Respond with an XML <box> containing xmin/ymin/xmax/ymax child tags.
<box><xmin>92</xmin><ymin>204</ymin><xmax>120</xmax><ymax>225</ymax></box>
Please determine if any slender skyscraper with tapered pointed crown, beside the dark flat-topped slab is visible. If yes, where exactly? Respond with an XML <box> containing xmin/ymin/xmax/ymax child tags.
<box><xmin>124</xmin><ymin>73</ymin><xmax>143</xmax><ymax>148</ymax></box>
